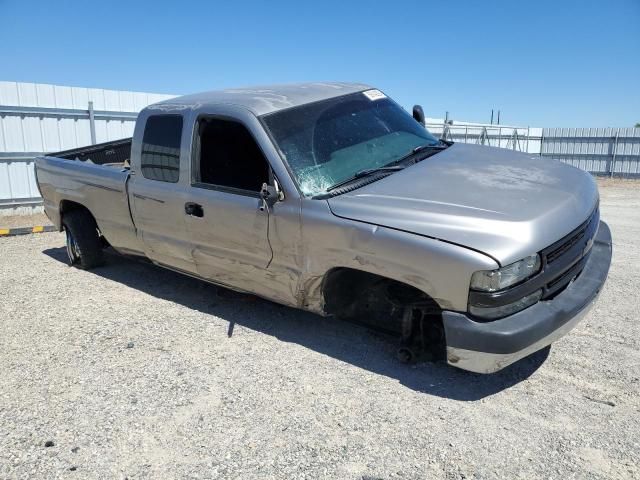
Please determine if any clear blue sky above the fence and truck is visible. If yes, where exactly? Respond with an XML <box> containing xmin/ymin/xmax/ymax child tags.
<box><xmin>0</xmin><ymin>0</ymin><xmax>640</xmax><ymax>127</ymax></box>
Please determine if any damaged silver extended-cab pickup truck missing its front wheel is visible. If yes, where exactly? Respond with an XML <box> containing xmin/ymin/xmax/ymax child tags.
<box><xmin>36</xmin><ymin>83</ymin><xmax>611</xmax><ymax>373</ymax></box>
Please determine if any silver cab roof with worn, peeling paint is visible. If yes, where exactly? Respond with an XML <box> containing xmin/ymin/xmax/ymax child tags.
<box><xmin>147</xmin><ymin>82</ymin><xmax>371</xmax><ymax>115</ymax></box>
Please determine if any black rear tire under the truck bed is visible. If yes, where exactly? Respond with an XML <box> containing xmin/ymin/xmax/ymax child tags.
<box><xmin>62</xmin><ymin>210</ymin><xmax>104</xmax><ymax>270</ymax></box>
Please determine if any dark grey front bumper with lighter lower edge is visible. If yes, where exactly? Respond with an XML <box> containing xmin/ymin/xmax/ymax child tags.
<box><xmin>442</xmin><ymin>222</ymin><xmax>611</xmax><ymax>373</ymax></box>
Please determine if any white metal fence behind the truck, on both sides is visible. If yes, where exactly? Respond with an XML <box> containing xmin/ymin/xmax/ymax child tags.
<box><xmin>0</xmin><ymin>82</ymin><xmax>640</xmax><ymax>215</ymax></box>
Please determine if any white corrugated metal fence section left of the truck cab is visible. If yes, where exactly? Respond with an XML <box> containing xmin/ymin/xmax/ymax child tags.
<box><xmin>0</xmin><ymin>81</ymin><xmax>174</xmax><ymax>213</ymax></box>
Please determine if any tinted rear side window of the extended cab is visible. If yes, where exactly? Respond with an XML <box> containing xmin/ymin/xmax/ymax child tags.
<box><xmin>141</xmin><ymin>115</ymin><xmax>182</xmax><ymax>183</ymax></box>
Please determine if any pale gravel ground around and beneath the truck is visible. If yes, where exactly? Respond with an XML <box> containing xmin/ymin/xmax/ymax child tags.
<box><xmin>0</xmin><ymin>182</ymin><xmax>640</xmax><ymax>480</ymax></box>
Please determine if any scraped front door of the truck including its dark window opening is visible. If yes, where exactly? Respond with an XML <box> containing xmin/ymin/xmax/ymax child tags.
<box><xmin>185</xmin><ymin>117</ymin><xmax>272</xmax><ymax>293</ymax></box>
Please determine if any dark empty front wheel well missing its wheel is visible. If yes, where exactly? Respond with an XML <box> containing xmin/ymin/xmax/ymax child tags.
<box><xmin>322</xmin><ymin>267</ymin><xmax>442</xmax><ymax>332</ymax></box>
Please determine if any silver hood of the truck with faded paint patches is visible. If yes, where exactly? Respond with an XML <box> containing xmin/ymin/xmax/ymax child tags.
<box><xmin>327</xmin><ymin>143</ymin><xmax>598</xmax><ymax>265</ymax></box>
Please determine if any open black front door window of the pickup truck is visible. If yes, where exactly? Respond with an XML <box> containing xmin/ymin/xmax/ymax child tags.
<box><xmin>195</xmin><ymin>118</ymin><xmax>269</xmax><ymax>193</ymax></box>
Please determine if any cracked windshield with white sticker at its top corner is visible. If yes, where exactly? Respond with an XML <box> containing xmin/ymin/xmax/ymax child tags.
<box><xmin>263</xmin><ymin>90</ymin><xmax>438</xmax><ymax>196</ymax></box>
